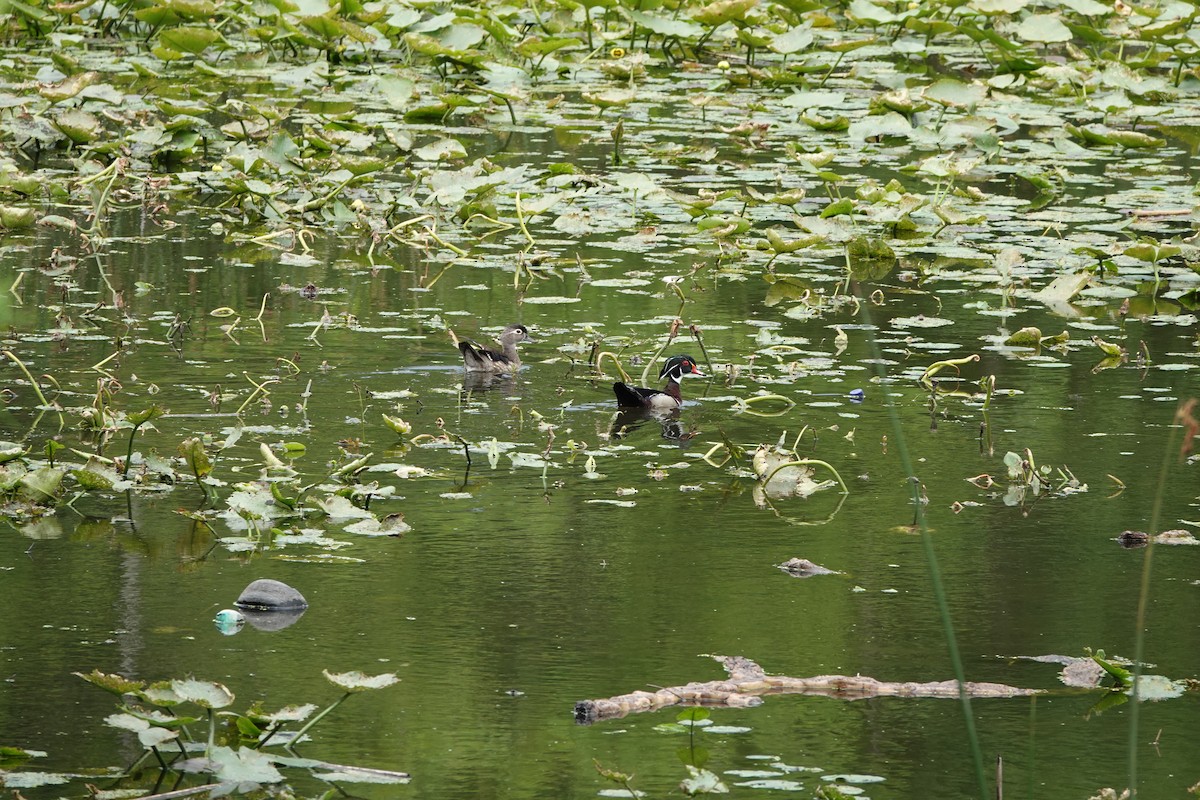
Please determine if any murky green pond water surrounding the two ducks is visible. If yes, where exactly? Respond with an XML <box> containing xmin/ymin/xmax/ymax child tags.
<box><xmin>0</xmin><ymin>9</ymin><xmax>1200</xmax><ymax>798</ymax></box>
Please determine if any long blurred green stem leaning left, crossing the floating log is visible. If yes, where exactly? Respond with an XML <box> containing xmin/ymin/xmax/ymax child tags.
<box><xmin>859</xmin><ymin>303</ymin><xmax>989</xmax><ymax>800</ymax></box>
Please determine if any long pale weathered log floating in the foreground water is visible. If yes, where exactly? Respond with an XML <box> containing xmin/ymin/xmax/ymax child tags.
<box><xmin>575</xmin><ymin>656</ymin><xmax>1040</xmax><ymax>724</ymax></box>
